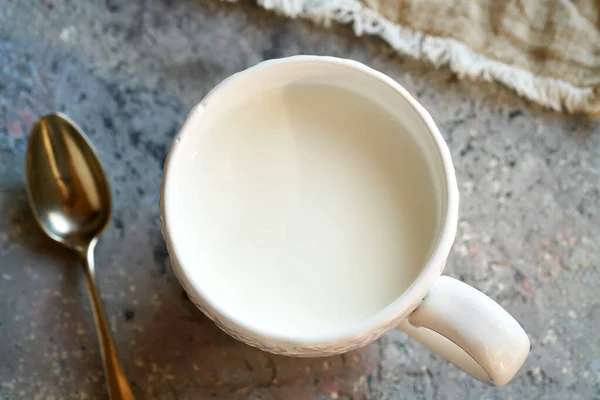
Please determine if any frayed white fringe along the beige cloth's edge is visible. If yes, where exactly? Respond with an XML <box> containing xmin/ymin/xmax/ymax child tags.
<box><xmin>244</xmin><ymin>0</ymin><xmax>600</xmax><ymax>118</ymax></box>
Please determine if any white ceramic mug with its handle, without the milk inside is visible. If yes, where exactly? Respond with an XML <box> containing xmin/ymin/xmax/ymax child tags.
<box><xmin>161</xmin><ymin>56</ymin><xmax>530</xmax><ymax>386</ymax></box>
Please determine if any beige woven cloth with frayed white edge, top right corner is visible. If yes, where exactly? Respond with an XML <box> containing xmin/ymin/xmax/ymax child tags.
<box><xmin>257</xmin><ymin>0</ymin><xmax>600</xmax><ymax>117</ymax></box>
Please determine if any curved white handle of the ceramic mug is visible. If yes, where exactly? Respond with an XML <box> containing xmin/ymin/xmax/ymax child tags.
<box><xmin>398</xmin><ymin>276</ymin><xmax>530</xmax><ymax>386</ymax></box>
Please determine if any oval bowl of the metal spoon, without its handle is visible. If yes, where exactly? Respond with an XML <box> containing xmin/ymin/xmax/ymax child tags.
<box><xmin>25</xmin><ymin>114</ymin><xmax>112</xmax><ymax>254</ymax></box>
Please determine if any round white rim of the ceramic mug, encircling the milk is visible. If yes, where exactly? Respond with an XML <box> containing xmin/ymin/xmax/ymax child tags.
<box><xmin>159</xmin><ymin>55</ymin><xmax>459</xmax><ymax>350</ymax></box>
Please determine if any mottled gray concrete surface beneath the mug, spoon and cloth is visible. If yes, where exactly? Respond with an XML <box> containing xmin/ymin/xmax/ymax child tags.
<box><xmin>0</xmin><ymin>0</ymin><xmax>600</xmax><ymax>400</ymax></box>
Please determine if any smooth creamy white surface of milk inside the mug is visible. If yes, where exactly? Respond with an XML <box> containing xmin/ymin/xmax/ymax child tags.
<box><xmin>171</xmin><ymin>85</ymin><xmax>438</xmax><ymax>336</ymax></box>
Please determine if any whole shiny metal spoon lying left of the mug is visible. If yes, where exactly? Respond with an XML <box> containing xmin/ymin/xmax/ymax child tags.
<box><xmin>25</xmin><ymin>114</ymin><xmax>133</xmax><ymax>400</ymax></box>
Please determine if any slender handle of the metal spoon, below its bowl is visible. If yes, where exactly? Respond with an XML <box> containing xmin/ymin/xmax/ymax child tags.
<box><xmin>83</xmin><ymin>241</ymin><xmax>134</xmax><ymax>400</ymax></box>
